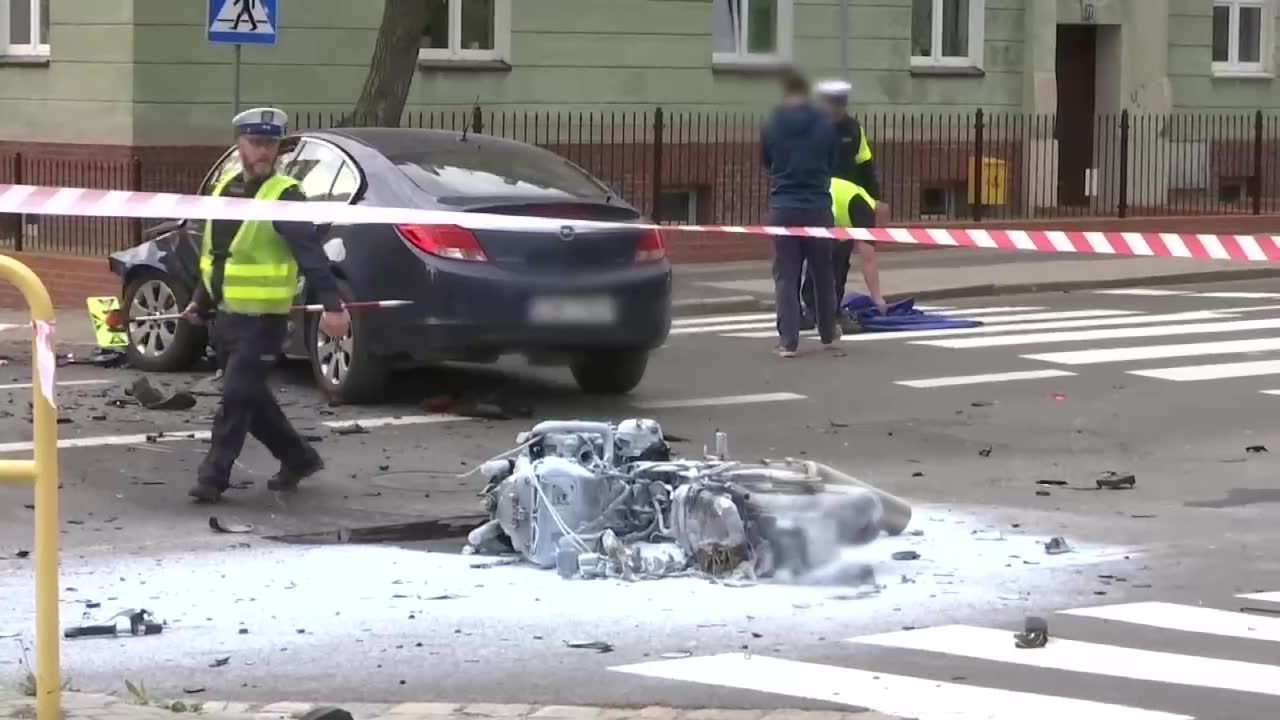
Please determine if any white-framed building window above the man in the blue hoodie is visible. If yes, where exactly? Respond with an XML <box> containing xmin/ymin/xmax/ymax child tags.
<box><xmin>712</xmin><ymin>0</ymin><xmax>794</xmax><ymax>65</ymax></box>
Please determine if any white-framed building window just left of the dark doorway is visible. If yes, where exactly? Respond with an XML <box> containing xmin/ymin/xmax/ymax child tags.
<box><xmin>911</xmin><ymin>0</ymin><xmax>986</xmax><ymax>68</ymax></box>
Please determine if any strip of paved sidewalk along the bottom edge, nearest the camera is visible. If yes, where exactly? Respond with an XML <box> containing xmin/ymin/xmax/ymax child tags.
<box><xmin>0</xmin><ymin>688</ymin><xmax>902</xmax><ymax>720</ymax></box>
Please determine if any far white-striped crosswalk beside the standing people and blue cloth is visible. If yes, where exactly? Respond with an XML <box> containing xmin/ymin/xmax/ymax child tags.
<box><xmin>672</xmin><ymin>288</ymin><xmax>1280</xmax><ymax>396</ymax></box>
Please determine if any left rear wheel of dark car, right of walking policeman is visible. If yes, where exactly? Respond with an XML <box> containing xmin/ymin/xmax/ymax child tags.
<box><xmin>306</xmin><ymin>282</ymin><xmax>388</xmax><ymax>405</ymax></box>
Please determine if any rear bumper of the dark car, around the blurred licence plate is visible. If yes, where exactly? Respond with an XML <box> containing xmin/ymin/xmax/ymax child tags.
<box><xmin>367</xmin><ymin>259</ymin><xmax>671</xmax><ymax>360</ymax></box>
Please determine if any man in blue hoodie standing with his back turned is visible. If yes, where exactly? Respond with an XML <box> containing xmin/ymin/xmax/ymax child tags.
<box><xmin>760</xmin><ymin>72</ymin><xmax>840</xmax><ymax>357</ymax></box>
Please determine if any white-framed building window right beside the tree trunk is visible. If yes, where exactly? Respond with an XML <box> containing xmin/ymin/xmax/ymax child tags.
<box><xmin>417</xmin><ymin>0</ymin><xmax>511</xmax><ymax>61</ymax></box>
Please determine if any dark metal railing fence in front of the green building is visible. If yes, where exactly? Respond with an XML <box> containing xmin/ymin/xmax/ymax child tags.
<box><xmin>0</xmin><ymin>108</ymin><xmax>1280</xmax><ymax>254</ymax></box>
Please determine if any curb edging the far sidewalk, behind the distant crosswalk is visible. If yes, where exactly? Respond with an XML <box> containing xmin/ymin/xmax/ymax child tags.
<box><xmin>672</xmin><ymin>268</ymin><xmax>1280</xmax><ymax>318</ymax></box>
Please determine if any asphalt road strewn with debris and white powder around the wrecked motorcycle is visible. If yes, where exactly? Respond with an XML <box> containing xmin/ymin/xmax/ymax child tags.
<box><xmin>0</xmin><ymin>281</ymin><xmax>1280</xmax><ymax>720</ymax></box>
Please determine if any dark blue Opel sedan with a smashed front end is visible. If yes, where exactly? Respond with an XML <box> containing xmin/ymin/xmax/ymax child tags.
<box><xmin>110</xmin><ymin>128</ymin><xmax>671</xmax><ymax>402</ymax></box>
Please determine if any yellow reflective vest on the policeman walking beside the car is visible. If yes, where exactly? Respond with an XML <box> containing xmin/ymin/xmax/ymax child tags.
<box><xmin>200</xmin><ymin>174</ymin><xmax>298</xmax><ymax>315</ymax></box>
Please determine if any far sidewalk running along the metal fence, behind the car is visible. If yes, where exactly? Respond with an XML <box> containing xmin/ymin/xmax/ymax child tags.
<box><xmin>0</xmin><ymin>249</ymin><xmax>1280</xmax><ymax>347</ymax></box>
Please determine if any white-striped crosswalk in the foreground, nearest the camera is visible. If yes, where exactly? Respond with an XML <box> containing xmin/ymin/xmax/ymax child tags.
<box><xmin>612</xmin><ymin>592</ymin><xmax>1280</xmax><ymax>720</ymax></box>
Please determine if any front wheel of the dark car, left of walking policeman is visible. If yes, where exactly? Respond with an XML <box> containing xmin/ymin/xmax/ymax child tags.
<box><xmin>122</xmin><ymin>269</ymin><xmax>209</xmax><ymax>373</ymax></box>
